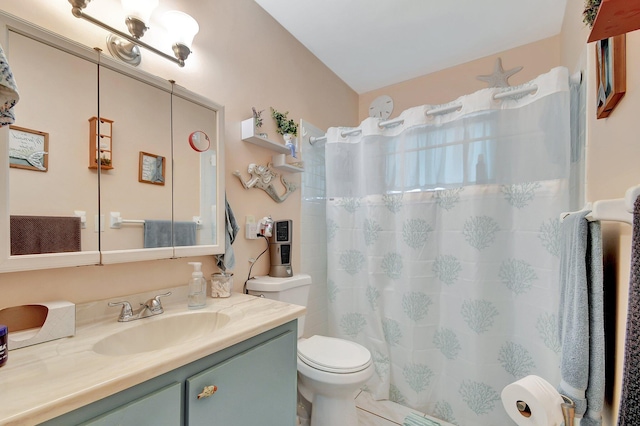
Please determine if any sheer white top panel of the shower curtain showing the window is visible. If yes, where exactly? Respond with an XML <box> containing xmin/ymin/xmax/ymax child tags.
<box><xmin>326</xmin><ymin>67</ymin><xmax>570</xmax><ymax>197</ymax></box>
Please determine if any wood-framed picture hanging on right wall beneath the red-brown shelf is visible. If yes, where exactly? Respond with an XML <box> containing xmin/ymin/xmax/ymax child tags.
<box><xmin>596</xmin><ymin>34</ymin><xmax>627</xmax><ymax>118</ymax></box>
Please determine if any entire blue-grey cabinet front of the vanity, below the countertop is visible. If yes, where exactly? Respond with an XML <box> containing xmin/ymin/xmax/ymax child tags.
<box><xmin>35</xmin><ymin>320</ymin><xmax>298</xmax><ymax>426</ymax></box>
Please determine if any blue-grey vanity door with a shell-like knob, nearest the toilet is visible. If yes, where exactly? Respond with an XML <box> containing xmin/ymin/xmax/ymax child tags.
<box><xmin>185</xmin><ymin>331</ymin><xmax>297</xmax><ymax>426</ymax></box>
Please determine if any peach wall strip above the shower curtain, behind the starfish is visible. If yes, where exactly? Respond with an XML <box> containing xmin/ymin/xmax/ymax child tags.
<box><xmin>360</xmin><ymin>36</ymin><xmax>560</xmax><ymax>122</ymax></box>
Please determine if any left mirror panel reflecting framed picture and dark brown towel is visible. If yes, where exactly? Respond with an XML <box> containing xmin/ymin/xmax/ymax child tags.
<box><xmin>8</xmin><ymin>31</ymin><xmax>98</xmax><ymax>259</ymax></box>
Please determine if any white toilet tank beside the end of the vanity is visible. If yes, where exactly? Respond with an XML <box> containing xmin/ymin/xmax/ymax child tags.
<box><xmin>247</xmin><ymin>274</ymin><xmax>311</xmax><ymax>337</ymax></box>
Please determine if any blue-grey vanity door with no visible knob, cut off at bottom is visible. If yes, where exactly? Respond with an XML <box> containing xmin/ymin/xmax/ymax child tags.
<box><xmin>82</xmin><ymin>383</ymin><xmax>182</xmax><ymax>426</ymax></box>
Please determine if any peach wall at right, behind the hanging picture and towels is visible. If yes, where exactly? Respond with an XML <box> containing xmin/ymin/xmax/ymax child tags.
<box><xmin>562</xmin><ymin>0</ymin><xmax>640</xmax><ymax>425</ymax></box>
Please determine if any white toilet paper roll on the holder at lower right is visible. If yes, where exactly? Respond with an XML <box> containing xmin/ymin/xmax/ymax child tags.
<box><xmin>501</xmin><ymin>375</ymin><xmax>564</xmax><ymax>426</ymax></box>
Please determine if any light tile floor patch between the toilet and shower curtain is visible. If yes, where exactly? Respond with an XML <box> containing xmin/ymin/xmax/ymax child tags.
<box><xmin>356</xmin><ymin>391</ymin><xmax>453</xmax><ymax>426</ymax></box>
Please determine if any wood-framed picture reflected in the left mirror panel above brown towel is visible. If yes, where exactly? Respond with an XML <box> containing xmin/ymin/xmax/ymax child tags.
<box><xmin>9</xmin><ymin>125</ymin><xmax>49</xmax><ymax>172</ymax></box>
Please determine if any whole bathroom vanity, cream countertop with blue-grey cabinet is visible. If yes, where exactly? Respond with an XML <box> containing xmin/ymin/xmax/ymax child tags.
<box><xmin>0</xmin><ymin>288</ymin><xmax>305</xmax><ymax>426</ymax></box>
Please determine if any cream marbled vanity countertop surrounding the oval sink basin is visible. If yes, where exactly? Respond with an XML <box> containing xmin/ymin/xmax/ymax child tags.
<box><xmin>0</xmin><ymin>291</ymin><xmax>305</xmax><ymax>425</ymax></box>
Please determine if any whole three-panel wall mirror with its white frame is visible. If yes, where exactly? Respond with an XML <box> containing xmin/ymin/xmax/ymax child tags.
<box><xmin>0</xmin><ymin>13</ymin><xmax>224</xmax><ymax>272</ymax></box>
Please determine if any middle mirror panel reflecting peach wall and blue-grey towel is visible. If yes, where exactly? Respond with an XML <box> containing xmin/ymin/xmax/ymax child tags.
<box><xmin>99</xmin><ymin>65</ymin><xmax>172</xmax><ymax>252</ymax></box>
